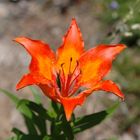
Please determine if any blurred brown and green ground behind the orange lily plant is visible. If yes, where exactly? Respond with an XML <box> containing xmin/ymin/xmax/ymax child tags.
<box><xmin>0</xmin><ymin>0</ymin><xmax>140</xmax><ymax>140</ymax></box>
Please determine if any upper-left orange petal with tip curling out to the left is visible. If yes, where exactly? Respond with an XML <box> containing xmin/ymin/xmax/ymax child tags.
<box><xmin>15</xmin><ymin>37</ymin><xmax>55</xmax><ymax>80</ymax></box>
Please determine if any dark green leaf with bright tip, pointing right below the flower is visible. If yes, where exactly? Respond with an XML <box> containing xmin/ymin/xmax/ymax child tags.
<box><xmin>73</xmin><ymin>103</ymin><xmax>119</xmax><ymax>133</ymax></box>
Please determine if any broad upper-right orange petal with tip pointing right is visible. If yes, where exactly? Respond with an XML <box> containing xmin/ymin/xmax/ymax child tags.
<box><xmin>79</xmin><ymin>44</ymin><xmax>125</xmax><ymax>87</ymax></box>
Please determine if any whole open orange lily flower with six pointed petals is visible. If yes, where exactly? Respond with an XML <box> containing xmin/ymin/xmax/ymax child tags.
<box><xmin>15</xmin><ymin>19</ymin><xmax>125</xmax><ymax>120</ymax></box>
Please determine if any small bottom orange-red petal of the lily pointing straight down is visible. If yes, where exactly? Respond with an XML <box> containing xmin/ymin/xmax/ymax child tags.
<box><xmin>60</xmin><ymin>94</ymin><xmax>85</xmax><ymax>121</ymax></box>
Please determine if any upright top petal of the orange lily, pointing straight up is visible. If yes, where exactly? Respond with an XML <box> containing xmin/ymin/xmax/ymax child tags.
<box><xmin>57</xmin><ymin>19</ymin><xmax>84</xmax><ymax>75</ymax></box>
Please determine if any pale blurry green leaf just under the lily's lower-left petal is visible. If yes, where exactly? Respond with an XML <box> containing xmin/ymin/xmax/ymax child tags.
<box><xmin>29</xmin><ymin>86</ymin><xmax>41</xmax><ymax>104</ymax></box>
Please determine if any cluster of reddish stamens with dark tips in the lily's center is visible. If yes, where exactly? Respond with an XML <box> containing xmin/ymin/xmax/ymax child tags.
<box><xmin>58</xmin><ymin>57</ymin><xmax>81</xmax><ymax>97</ymax></box>
